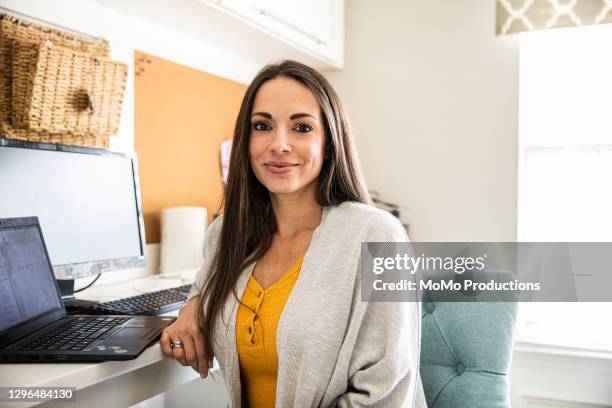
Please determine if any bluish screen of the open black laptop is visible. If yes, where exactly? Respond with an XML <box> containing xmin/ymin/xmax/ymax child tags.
<box><xmin>0</xmin><ymin>225</ymin><xmax>62</xmax><ymax>332</ymax></box>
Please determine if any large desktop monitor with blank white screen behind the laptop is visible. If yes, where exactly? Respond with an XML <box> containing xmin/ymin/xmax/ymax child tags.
<box><xmin>0</xmin><ymin>138</ymin><xmax>146</xmax><ymax>302</ymax></box>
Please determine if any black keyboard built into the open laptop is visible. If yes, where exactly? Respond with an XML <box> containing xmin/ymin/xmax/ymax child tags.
<box><xmin>17</xmin><ymin>317</ymin><xmax>131</xmax><ymax>350</ymax></box>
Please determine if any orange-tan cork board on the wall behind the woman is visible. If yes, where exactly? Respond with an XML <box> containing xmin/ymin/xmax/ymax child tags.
<box><xmin>134</xmin><ymin>51</ymin><xmax>246</xmax><ymax>243</ymax></box>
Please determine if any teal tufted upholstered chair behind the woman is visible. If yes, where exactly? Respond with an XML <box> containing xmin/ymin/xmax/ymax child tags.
<box><xmin>421</xmin><ymin>270</ymin><xmax>518</xmax><ymax>408</ymax></box>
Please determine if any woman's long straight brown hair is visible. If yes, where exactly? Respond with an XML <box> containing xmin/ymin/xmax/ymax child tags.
<box><xmin>197</xmin><ymin>61</ymin><xmax>370</xmax><ymax>355</ymax></box>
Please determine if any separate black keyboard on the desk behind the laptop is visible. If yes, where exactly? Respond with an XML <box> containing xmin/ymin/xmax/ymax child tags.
<box><xmin>68</xmin><ymin>284</ymin><xmax>191</xmax><ymax>315</ymax></box>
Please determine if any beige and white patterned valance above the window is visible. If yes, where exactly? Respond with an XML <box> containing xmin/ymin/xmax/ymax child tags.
<box><xmin>496</xmin><ymin>0</ymin><xmax>612</xmax><ymax>34</ymax></box>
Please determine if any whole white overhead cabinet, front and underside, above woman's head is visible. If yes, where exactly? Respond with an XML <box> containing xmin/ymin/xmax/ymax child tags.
<box><xmin>89</xmin><ymin>0</ymin><xmax>346</xmax><ymax>71</ymax></box>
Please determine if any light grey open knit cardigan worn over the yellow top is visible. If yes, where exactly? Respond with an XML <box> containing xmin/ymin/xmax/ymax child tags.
<box><xmin>189</xmin><ymin>202</ymin><xmax>427</xmax><ymax>408</ymax></box>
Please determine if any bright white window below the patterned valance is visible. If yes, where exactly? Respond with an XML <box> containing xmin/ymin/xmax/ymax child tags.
<box><xmin>517</xmin><ymin>24</ymin><xmax>612</xmax><ymax>350</ymax></box>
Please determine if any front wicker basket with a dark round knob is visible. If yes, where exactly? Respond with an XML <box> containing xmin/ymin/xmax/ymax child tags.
<box><xmin>12</xmin><ymin>41</ymin><xmax>128</xmax><ymax>135</ymax></box>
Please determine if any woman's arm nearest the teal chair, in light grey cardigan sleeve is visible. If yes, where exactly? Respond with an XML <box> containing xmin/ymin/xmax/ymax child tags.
<box><xmin>337</xmin><ymin>212</ymin><xmax>422</xmax><ymax>408</ymax></box>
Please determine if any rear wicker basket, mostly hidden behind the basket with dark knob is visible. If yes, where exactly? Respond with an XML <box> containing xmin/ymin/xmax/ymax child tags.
<box><xmin>0</xmin><ymin>14</ymin><xmax>118</xmax><ymax>147</ymax></box>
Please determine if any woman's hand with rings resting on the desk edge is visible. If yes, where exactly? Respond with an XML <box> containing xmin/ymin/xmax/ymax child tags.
<box><xmin>160</xmin><ymin>296</ymin><xmax>213</xmax><ymax>378</ymax></box>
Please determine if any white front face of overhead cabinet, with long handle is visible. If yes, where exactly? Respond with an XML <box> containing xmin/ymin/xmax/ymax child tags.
<box><xmin>209</xmin><ymin>0</ymin><xmax>344</xmax><ymax>68</ymax></box>
